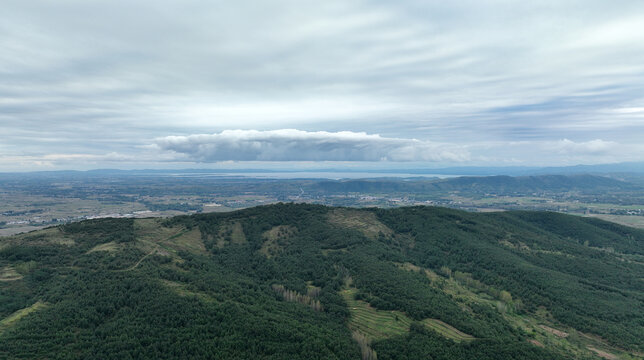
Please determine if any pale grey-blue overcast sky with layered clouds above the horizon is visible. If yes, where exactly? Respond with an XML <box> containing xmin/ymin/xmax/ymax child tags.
<box><xmin>0</xmin><ymin>0</ymin><xmax>644</xmax><ymax>171</ymax></box>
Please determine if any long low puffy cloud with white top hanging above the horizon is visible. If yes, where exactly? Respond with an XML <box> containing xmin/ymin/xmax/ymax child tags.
<box><xmin>155</xmin><ymin>129</ymin><xmax>470</xmax><ymax>162</ymax></box>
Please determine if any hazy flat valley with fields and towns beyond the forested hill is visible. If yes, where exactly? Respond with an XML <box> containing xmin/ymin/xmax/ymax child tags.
<box><xmin>0</xmin><ymin>171</ymin><xmax>644</xmax><ymax>236</ymax></box>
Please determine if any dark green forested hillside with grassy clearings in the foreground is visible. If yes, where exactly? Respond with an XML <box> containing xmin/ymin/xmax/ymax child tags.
<box><xmin>0</xmin><ymin>204</ymin><xmax>644</xmax><ymax>360</ymax></box>
